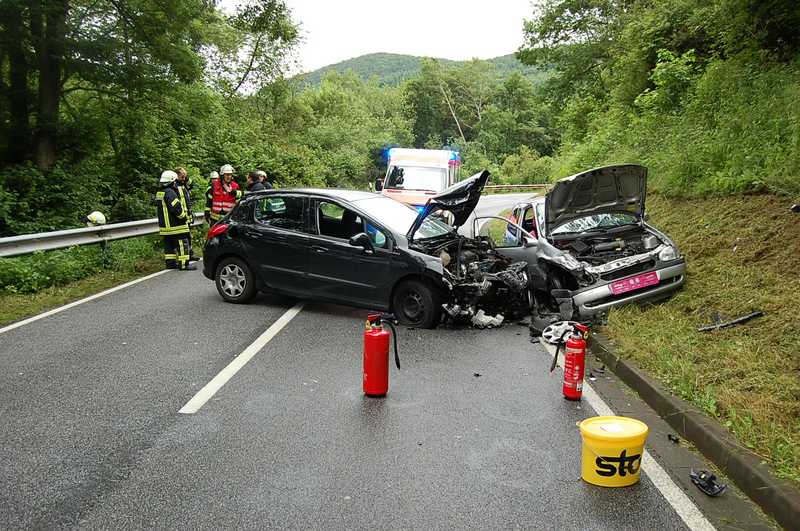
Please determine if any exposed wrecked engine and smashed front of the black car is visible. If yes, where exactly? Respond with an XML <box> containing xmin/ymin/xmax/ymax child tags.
<box><xmin>412</xmin><ymin>236</ymin><xmax>530</xmax><ymax>328</ymax></box>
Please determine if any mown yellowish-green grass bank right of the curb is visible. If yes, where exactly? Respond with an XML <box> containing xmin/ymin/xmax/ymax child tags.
<box><xmin>606</xmin><ymin>195</ymin><xmax>800</xmax><ymax>483</ymax></box>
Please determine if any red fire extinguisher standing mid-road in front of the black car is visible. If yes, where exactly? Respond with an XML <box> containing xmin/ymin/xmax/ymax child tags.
<box><xmin>364</xmin><ymin>314</ymin><xmax>400</xmax><ymax>397</ymax></box>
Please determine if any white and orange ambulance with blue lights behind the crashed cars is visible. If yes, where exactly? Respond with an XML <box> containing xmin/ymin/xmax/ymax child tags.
<box><xmin>381</xmin><ymin>148</ymin><xmax>461</xmax><ymax>211</ymax></box>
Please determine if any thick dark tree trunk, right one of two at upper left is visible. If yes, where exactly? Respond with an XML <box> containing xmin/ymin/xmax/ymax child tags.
<box><xmin>31</xmin><ymin>0</ymin><xmax>69</xmax><ymax>171</ymax></box>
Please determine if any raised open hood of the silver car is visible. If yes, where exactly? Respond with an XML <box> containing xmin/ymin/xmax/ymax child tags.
<box><xmin>544</xmin><ymin>164</ymin><xmax>647</xmax><ymax>234</ymax></box>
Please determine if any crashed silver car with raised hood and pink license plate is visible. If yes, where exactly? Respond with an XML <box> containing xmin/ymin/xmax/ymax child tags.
<box><xmin>474</xmin><ymin>164</ymin><xmax>686</xmax><ymax>331</ymax></box>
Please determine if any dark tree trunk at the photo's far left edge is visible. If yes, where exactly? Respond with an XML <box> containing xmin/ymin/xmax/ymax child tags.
<box><xmin>0</xmin><ymin>2</ymin><xmax>30</xmax><ymax>163</ymax></box>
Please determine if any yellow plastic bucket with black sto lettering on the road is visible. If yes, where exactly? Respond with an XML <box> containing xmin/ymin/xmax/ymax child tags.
<box><xmin>578</xmin><ymin>417</ymin><xmax>649</xmax><ymax>487</ymax></box>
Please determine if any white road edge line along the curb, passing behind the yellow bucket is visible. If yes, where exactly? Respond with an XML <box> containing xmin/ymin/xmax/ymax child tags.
<box><xmin>540</xmin><ymin>341</ymin><xmax>716</xmax><ymax>531</ymax></box>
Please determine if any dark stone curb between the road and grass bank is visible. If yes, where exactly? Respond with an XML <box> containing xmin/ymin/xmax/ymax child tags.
<box><xmin>589</xmin><ymin>332</ymin><xmax>800</xmax><ymax>529</ymax></box>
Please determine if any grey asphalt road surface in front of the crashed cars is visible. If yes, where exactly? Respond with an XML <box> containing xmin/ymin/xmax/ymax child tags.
<box><xmin>0</xmin><ymin>196</ymin><xmax>776</xmax><ymax>530</ymax></box>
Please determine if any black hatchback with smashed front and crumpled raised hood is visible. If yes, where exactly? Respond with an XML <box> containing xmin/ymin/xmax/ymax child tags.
<box><xmin>203</xmin><ymin>171</ymin><xmax>527</xmax><ymax>327</ymax></box>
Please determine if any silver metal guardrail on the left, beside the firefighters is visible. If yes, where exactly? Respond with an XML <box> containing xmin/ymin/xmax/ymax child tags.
<box><xmin>0</xmin><ymin>212</ymin><xmax>203</xmax><ymax>257</ymax></box>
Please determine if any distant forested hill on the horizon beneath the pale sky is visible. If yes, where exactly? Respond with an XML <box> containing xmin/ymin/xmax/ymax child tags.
<box><xmin>296</xmin><ymin>53</ymin><xmax>545</xmax><ymax>86</ymax></box>
